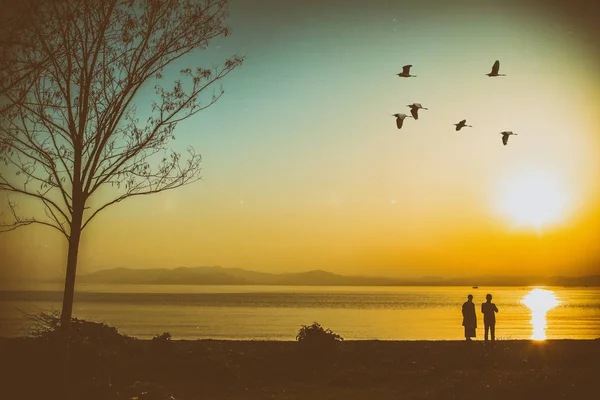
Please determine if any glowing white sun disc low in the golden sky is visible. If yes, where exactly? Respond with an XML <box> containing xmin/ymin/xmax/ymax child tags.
<box><xmin>497</xmin><ymin>171</ymin><xmax>567</xmax><ymax>230</ymax></box>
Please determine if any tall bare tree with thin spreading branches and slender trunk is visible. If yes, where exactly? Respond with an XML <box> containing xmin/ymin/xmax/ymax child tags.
<box><xmin>0</xmin><ymin>0</ymin><xmax>243</xmax><ymax>329</ymax></box>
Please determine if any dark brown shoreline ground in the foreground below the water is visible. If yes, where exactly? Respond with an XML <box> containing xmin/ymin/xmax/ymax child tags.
<box><xmin>0</xmin><ymin>339</ymin><xmax>600</xmax><ymax>400</ymax></box>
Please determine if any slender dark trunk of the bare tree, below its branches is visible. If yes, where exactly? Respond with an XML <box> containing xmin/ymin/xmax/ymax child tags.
<box><xmin>60</xmin><ymin>206</ymin><xmax>83</xmax><ymax>334</ymax></box>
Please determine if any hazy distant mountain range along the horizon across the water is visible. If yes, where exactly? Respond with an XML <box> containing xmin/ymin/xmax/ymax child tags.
<box><xmin>77</xmin><ymin>267</ymin><xmax>600</xmax><ymax>286</ymax></box>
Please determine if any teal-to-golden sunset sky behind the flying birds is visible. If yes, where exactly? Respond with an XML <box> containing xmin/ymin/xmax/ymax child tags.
<box><xmin>0</xmin><ymin>0</ymin><xmax>600</xmax><ymax>279</ymax></box>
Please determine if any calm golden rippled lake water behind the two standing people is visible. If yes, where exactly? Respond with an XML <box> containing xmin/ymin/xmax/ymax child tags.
<box><xmin>0</xmin><ymin>284</ymin><xmax>600</xmax><ymax>340</ymax></box>
